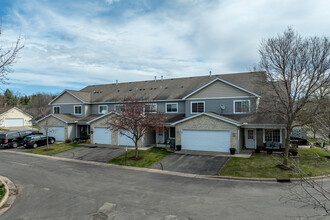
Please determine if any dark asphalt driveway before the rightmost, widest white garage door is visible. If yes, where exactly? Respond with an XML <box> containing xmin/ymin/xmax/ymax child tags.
<box><xmin>150</xmin><ymin>153</ymin><xmax>228</xmax><ymax>175</ymax></box>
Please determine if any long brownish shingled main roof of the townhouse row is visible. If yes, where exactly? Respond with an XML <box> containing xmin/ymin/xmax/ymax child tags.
<box><xmin>76</xmin><ymin>72</ymin><xmax>266</xmax><ymax>103</ymax></box>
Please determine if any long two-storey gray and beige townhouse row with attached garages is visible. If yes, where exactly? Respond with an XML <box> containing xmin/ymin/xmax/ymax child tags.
<box><xmin>38</xmin><ymin>72</ymin><xmax>287</xmax><ymax>152</ymax></box>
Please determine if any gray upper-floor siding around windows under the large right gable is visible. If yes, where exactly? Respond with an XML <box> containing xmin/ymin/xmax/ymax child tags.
<box><xmin>185</xmin><ymin>97</ymin><xmax>257</xmax><ymax>117</ymax></box>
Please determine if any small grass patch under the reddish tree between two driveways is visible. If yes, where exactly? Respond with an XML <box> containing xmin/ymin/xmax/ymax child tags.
<box><xmin>108</xmin><ymin>147</ymin><xmax>171</xmax><ymax>167</ymax></box>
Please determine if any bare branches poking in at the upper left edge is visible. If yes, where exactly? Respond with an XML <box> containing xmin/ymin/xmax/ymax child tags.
<box><xmin>0</xmin><ymin>21</ymin><xmax>24</xmax><ymax>83</ymax></box>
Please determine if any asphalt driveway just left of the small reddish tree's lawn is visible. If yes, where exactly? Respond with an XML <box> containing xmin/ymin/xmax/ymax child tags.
<box><xmin>54</xmin><ymin>145</ymin><xmax>125</xmax><ymax>163</ymax></box>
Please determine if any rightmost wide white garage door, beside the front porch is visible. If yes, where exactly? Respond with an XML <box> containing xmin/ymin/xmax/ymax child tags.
<box><xmin>181</xmin><ymin>130</ymin><xmax>230</xmax><ymax>152</ymax></box>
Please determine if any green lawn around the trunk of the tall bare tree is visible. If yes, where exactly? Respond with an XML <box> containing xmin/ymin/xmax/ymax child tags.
<box><xmin>219</xmin><ymin>149</ymin><xmax>330</xmax><ymax>178</ymax></box>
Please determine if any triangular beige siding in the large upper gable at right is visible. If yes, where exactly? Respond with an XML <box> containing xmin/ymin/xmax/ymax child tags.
<box><xmin>188</xmin><ymin>81</ymin><xmax>251</xmax><ymax>99</ymax></box>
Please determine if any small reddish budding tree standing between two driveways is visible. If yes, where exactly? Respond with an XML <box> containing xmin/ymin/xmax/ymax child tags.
<box><xmin>107</xmin><ymin>96</ymin><xmax>165</xmax><ymax>159</ymax></box>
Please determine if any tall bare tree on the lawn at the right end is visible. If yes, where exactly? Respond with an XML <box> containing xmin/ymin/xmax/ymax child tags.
<box><xmin>258</xmin><ymin>28</ymin><xmax>330</xmax><ymax>165</ymax></box>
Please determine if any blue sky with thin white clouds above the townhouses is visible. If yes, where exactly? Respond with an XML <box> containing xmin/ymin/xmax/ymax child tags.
<box><xmin>0</xmin><ymin>0</ymin><xmax>330</xmax><ymax>94</ymax></box>
